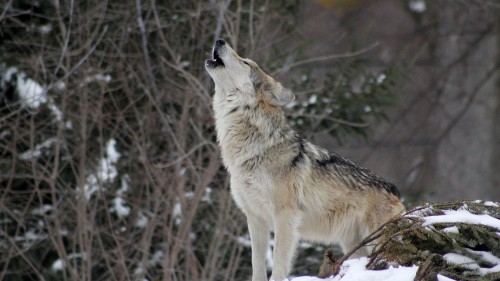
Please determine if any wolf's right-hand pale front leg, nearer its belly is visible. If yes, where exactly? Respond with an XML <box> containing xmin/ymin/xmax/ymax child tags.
<box><xmin>270</xmin><ymin>210</ymin><xmax>300</xmax><ymax>281</ymax></box>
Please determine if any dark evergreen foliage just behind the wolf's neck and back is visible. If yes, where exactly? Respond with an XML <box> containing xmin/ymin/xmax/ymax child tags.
<box><xmin>289</xmin><ymin>58</ymin><xmax>411</xmax><ymax>141</ymax></box>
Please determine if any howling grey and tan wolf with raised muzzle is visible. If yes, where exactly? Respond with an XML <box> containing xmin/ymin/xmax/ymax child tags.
<box><xmin>205</xmin><ymin>39</ymin><xmax>404</xmax><ymax>281</ymax></box>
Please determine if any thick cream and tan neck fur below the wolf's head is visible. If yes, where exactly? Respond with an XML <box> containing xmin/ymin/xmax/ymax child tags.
<box><xmin>213</xmin><ymin>88</ymin><xmax>296</xmax><ymax>172</ymax></box>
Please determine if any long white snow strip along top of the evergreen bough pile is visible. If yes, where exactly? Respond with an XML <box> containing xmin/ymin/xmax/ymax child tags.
<box><xmin>422</xmin><ymin>210</ymin><xmax>500</xmax><ymax>230</ymax></box>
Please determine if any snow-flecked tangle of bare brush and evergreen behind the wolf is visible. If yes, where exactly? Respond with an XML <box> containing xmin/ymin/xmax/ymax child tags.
<box><xmin>0</xmin><ymin>0</ymin><xmax>403</xmax><ymax>280</ymax></box>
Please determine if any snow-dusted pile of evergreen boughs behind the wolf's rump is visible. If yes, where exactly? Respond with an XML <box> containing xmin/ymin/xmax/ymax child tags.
<box><xmin>367</xmin><ymin>200</ymin><xmax>500</xmax><ymax>280</ymax></box>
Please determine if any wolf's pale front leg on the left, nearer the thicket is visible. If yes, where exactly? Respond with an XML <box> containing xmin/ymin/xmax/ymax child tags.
<box><xmin>247</xmin><ymin>215</ymin><xmax>270</xmax><ymax>281</ymax></box>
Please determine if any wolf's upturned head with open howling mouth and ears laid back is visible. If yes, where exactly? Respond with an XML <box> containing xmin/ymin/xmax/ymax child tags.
<box><xmin>205</xmin><ymin>39</ymin><xmax>295</xmax><ymax>107</ymax></box>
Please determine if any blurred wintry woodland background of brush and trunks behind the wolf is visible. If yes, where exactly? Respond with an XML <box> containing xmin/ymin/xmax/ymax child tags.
<box><xmin>0</xmin><ymin>0</ymin><xmax>500</xmax><ymax>280</ymax></box>
